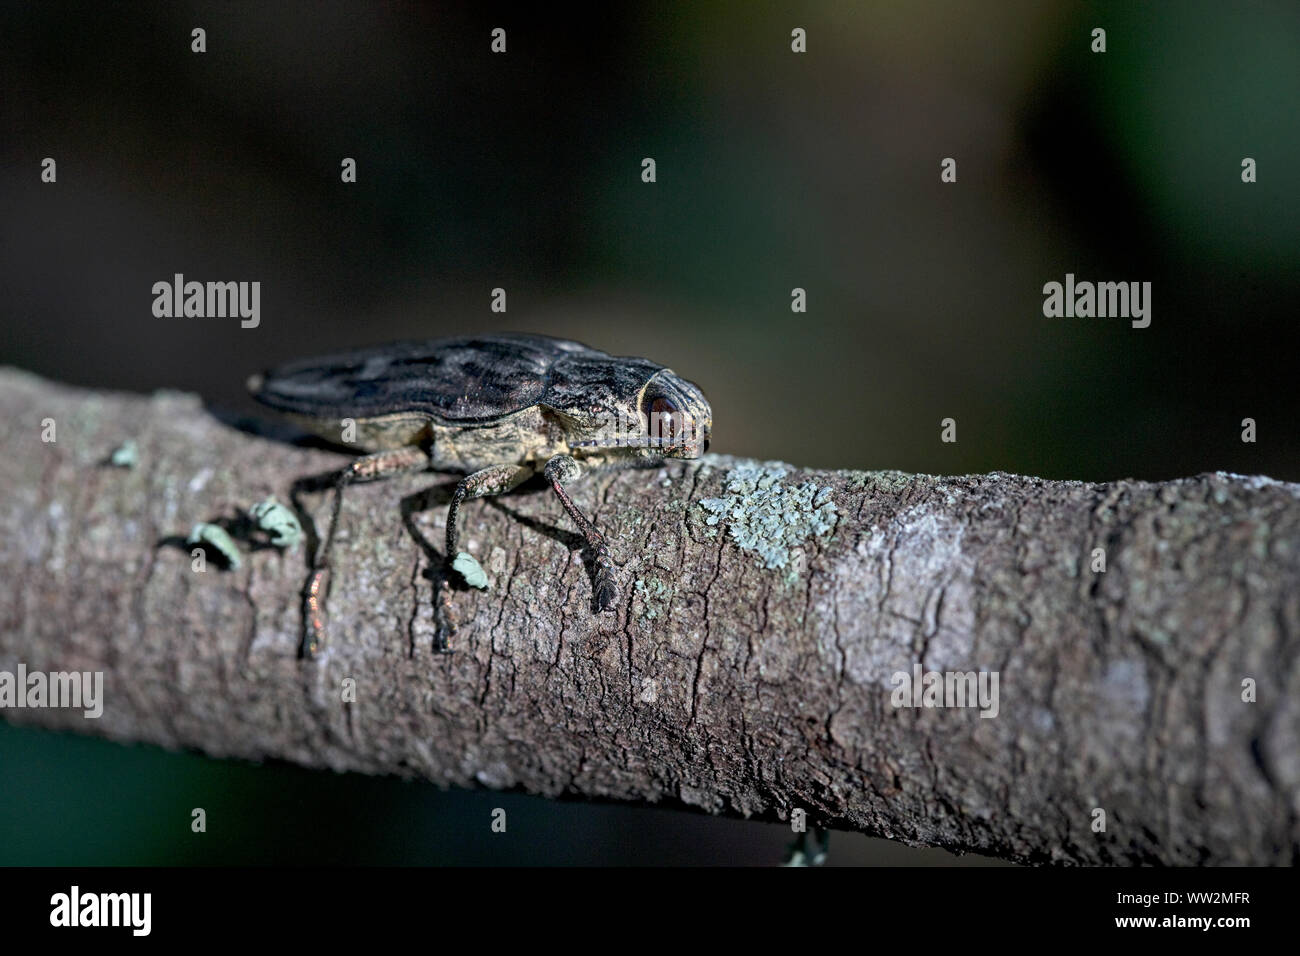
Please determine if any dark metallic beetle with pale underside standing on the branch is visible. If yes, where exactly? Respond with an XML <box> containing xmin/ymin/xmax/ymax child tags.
<box><xmin>248</xmin><ymin>333</ymin><xmax>712</xmax><ymax>657</ymax></box>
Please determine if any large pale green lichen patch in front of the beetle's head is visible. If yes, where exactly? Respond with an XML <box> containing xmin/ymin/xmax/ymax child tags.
<box><xmin>699</xmin><ymin>463</ymin><xmax>839</xmax><ymax>570</ymax></box>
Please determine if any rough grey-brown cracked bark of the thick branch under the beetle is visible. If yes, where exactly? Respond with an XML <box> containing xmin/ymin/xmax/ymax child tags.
<box><xmin>0</xmin><ymin>371</ymin><xmax>1300</xmax><ymax>864</ymax></box>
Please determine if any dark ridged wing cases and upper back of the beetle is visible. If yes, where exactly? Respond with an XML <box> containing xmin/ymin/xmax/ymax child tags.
<box><xmin>254</xmin><ymin>333</ymin><xmax>663</xmax><ymax>424</ymax></box>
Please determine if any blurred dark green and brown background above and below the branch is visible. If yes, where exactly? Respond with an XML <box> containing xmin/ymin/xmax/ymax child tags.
<box><xmin>0</xmin><ymin>0</ymin><xmax>1300</xmax><ymax>865</ymax></box>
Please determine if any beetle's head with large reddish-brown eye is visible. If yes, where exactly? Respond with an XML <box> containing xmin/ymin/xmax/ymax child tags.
<box><xmin>569</xmin><ymin>368</ymin><xmax>714</xmax><ymax>459</ymax></box>
